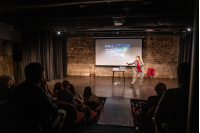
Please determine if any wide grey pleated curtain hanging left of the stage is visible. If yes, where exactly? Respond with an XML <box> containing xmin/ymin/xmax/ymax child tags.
<box><xmin>13</xmin><ymin>30</ymin><xmax>66</xmax><ymax>82</ymax></box>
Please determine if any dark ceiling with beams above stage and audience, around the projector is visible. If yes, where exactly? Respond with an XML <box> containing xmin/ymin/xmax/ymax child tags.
<box><xmin>0</xmin><ymin>0</ymin><xmax>195</xmax><ymax>35</ymax></box>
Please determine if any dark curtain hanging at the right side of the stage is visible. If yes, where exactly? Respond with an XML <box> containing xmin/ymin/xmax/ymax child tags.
<box><xmin>178</xmin><ymin>31</ymin><xmax>192</xmax><ymax>64</ymax></box>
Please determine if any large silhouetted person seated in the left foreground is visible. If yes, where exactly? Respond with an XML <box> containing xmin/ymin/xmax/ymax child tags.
<box><xmin>4</xmin><ymin>63</ymin><xmax>66</xmax><ymax>132</ymax></box>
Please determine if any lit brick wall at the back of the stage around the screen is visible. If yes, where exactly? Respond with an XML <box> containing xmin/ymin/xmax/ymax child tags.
<box><xmin>66</xmin><ymin>35</ymin><xmax>179</xmax><ymax>78</ymax></box>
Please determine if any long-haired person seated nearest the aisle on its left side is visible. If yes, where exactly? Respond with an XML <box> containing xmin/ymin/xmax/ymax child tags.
<box><xmin>83</xmin><ymin>86</ymin><xmax>100</xmax><ymax>103</ymax></box>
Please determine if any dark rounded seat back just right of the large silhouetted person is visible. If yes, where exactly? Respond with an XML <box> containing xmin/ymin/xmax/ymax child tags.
<box><xmin>56</xmin><ymin>102</ymin><xmax>78</xmax><ymax>122</ymax></box>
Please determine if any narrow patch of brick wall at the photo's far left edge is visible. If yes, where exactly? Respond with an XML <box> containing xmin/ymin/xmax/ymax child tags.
<box><xmin>0</xmin><ymin>40</ymin><xmax>14</xmax><ymax>76</ymax></box>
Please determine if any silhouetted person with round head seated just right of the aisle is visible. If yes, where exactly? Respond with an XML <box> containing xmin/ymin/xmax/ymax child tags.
<box><xmin>141</xmin><ymin>83</ymin><xmax>167</xmax><ymax>121</ymax></box>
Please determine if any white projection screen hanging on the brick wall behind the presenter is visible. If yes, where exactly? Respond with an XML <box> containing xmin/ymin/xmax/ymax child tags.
<box><xmin>95</xmin><ymin>39</ymin><xmax>142</xmax><ymax>66</ymax></box>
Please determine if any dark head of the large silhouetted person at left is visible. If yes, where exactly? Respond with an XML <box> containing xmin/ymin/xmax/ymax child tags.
<box><xmin>25</xmin><ymin>63</ymin><xmax>44</xmax><ymax>84</ymax></box>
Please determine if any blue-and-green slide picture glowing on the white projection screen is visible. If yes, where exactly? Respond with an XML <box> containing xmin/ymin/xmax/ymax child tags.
<box><xmin>105</xmin><ymin>44</ymin><xmax>130</xmax><ymax>59</ymax></box>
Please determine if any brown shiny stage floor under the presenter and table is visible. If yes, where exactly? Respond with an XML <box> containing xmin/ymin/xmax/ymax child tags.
<box><xmin>48</xmin><ymin>76</ymin><xmax>178</xmax><ymax>99</ymax></box>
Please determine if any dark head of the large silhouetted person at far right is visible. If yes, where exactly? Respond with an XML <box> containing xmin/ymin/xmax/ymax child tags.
<box><xmin>177</xmin><ymin>62</ymin><xmax>191</xmax><ymax>85</ymax></box>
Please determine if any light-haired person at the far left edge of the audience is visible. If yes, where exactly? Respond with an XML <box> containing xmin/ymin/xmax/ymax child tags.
<box><xmin>0</xmin><ymin>75</ymin><xmax>15</xmax><ymax>101</ymax></box>
